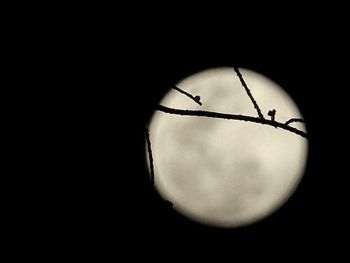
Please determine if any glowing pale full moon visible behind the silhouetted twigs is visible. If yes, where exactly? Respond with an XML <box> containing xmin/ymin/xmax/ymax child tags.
<box><xmin>146</xmin><ymin>67</ymin><xmax>308</xmax><ymax>228</ymax></box>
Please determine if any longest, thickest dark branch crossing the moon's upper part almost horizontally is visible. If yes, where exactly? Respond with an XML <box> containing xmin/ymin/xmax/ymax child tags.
<box><xmin>157</xmin><ymin>105</ymin><xmax>308</xmax><ymax>138</ymax></box>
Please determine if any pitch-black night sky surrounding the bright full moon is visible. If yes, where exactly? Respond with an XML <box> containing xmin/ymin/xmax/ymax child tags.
<box><xmin>4</xmin><ymin>5</ymin><xmax>349</xmax><ymax>262</ymax></box>
